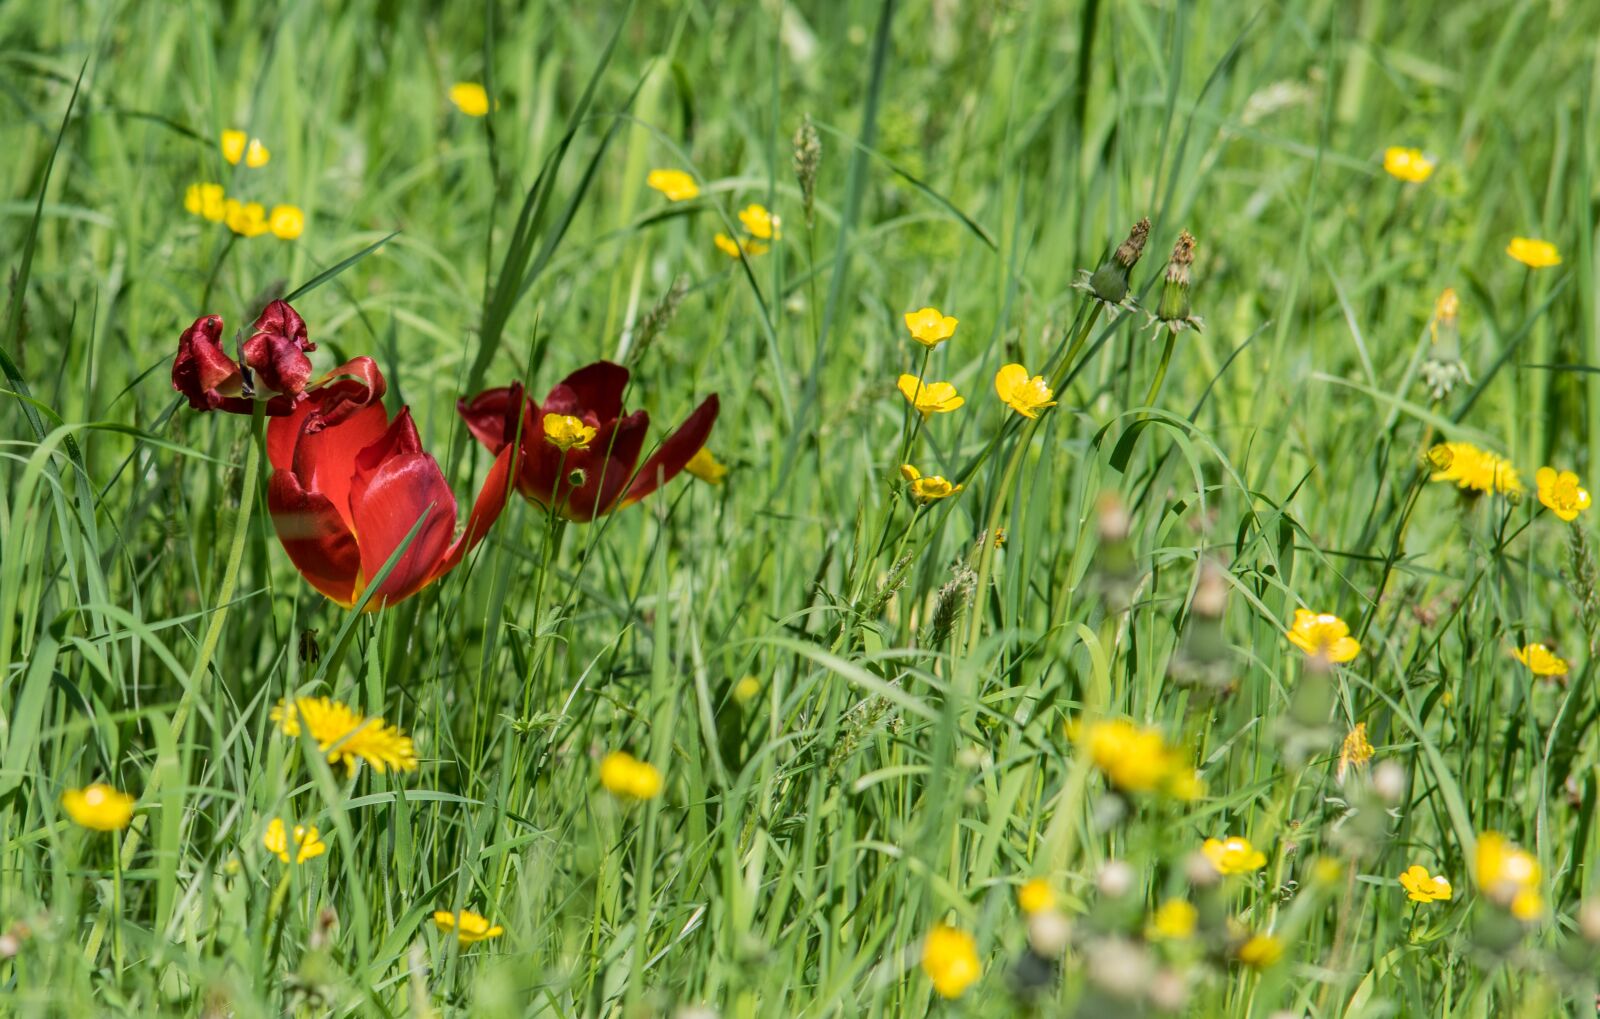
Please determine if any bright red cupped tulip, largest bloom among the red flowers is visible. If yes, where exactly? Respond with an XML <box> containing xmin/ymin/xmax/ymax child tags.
<box><xmin>267</xmin><ymin>359</ymin><xmax>515</xmax><ymax>609</ymax></box>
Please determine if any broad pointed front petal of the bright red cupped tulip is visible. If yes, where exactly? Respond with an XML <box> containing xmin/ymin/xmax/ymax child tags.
<box><xmin>347</xmin><ymin>410</ymin><xmax>456</xmax><ymax>605</ymax></box>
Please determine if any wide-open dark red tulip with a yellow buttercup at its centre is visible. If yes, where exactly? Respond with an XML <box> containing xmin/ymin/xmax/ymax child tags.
<box><xmin>458</xmin><ymin>362</ymin><xmax>718</xmax><ymax>521</ymax></box>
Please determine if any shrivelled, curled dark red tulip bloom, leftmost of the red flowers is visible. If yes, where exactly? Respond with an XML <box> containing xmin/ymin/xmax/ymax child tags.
<box><xmin>173</xmin><ymin>301</ymin><xmax>317</xmax><ymax>416</ymax></box>
